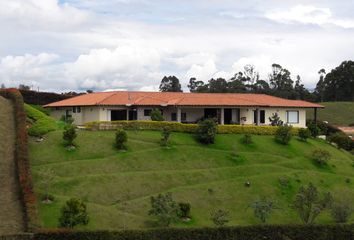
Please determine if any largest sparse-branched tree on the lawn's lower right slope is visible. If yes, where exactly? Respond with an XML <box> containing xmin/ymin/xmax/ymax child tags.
<box><xmin>294</xmin><ymin>183</ymin><xmax>332</xmax><ymax>224</ymax></box>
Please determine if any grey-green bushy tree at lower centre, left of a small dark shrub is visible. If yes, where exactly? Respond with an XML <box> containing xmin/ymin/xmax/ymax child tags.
<box><xmin>149</xmin><ymin>193</ymin><xmax>180</xmax><ymax>227</ymax></box>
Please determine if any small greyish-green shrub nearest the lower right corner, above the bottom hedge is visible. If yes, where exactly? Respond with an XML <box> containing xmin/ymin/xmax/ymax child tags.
<box><xmin>331</xmin><ymin>193</ymin><xmax>353</xmax><ymax>223</ymax></box>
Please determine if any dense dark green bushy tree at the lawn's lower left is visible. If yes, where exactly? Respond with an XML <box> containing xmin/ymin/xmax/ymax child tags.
<box><xmin>59</xmin><ymin>198</ymin><xmax>89</xmax><ymax>228</ymax></box>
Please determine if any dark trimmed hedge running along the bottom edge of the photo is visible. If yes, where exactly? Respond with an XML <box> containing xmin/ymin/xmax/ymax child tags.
<box><xmin>35</xmin><ymin>225</ymin><xmax>354</xmax><ymax>240</ymax></box>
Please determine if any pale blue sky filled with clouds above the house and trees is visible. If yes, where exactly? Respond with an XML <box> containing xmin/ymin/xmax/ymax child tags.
<box><xmin>0</xmin><ymin>0</ymin><xmax>354</xmax><ymax>92</ymax></box>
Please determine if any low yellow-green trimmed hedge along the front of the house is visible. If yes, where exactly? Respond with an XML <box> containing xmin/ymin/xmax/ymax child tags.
<box><xmin>85</xmin><ymin>121</ymin><xmax>299</xmax><ymax>135</ymax></box>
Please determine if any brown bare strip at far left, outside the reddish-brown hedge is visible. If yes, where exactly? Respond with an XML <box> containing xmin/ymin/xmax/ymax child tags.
<box><xmin>0</xmin><ymin>97</ymin><xmax>24</xmax><ymax>235</ymax></box>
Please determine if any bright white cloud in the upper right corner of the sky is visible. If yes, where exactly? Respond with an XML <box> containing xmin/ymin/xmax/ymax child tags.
<box><xmin>266</xmin><ymin>5</ymin><xmax>354</xmax><ymax>28</ymax></box>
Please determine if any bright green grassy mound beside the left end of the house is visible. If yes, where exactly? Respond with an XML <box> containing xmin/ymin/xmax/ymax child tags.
<box><xmin>24</xmin><ymin>104</ymin><xmax>64</xmax><ymax>136</ymax></box>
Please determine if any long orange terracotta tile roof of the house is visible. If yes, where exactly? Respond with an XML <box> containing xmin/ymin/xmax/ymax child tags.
<box><xmin>45</xmin><ymin>91</ymin><xmax>323</xmax><ymax>108</ymax></box>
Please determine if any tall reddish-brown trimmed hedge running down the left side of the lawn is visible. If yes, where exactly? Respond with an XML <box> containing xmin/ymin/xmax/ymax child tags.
<box><xmin>0</xmin><ymin>89</ymin><xmax>38</xmax><ymax>231</ymax></box>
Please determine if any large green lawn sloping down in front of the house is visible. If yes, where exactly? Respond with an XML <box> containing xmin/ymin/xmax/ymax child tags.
<box><xmin>30</xmin><ymin>131</ymin><xmax>354</xmax><ymax>230</ymax></box>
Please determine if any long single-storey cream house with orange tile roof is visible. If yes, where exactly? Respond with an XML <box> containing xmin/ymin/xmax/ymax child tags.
<box><xmin>45</xmin><ymin>91</ymin><xmax>323</xmax><ymax>127</ymax></box>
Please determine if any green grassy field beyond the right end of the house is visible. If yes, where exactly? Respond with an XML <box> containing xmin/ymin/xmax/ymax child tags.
<box><xmin>306</xmin><ymin>102</ymin><xmax>354</xmax><ymax>126</ymax></box>
